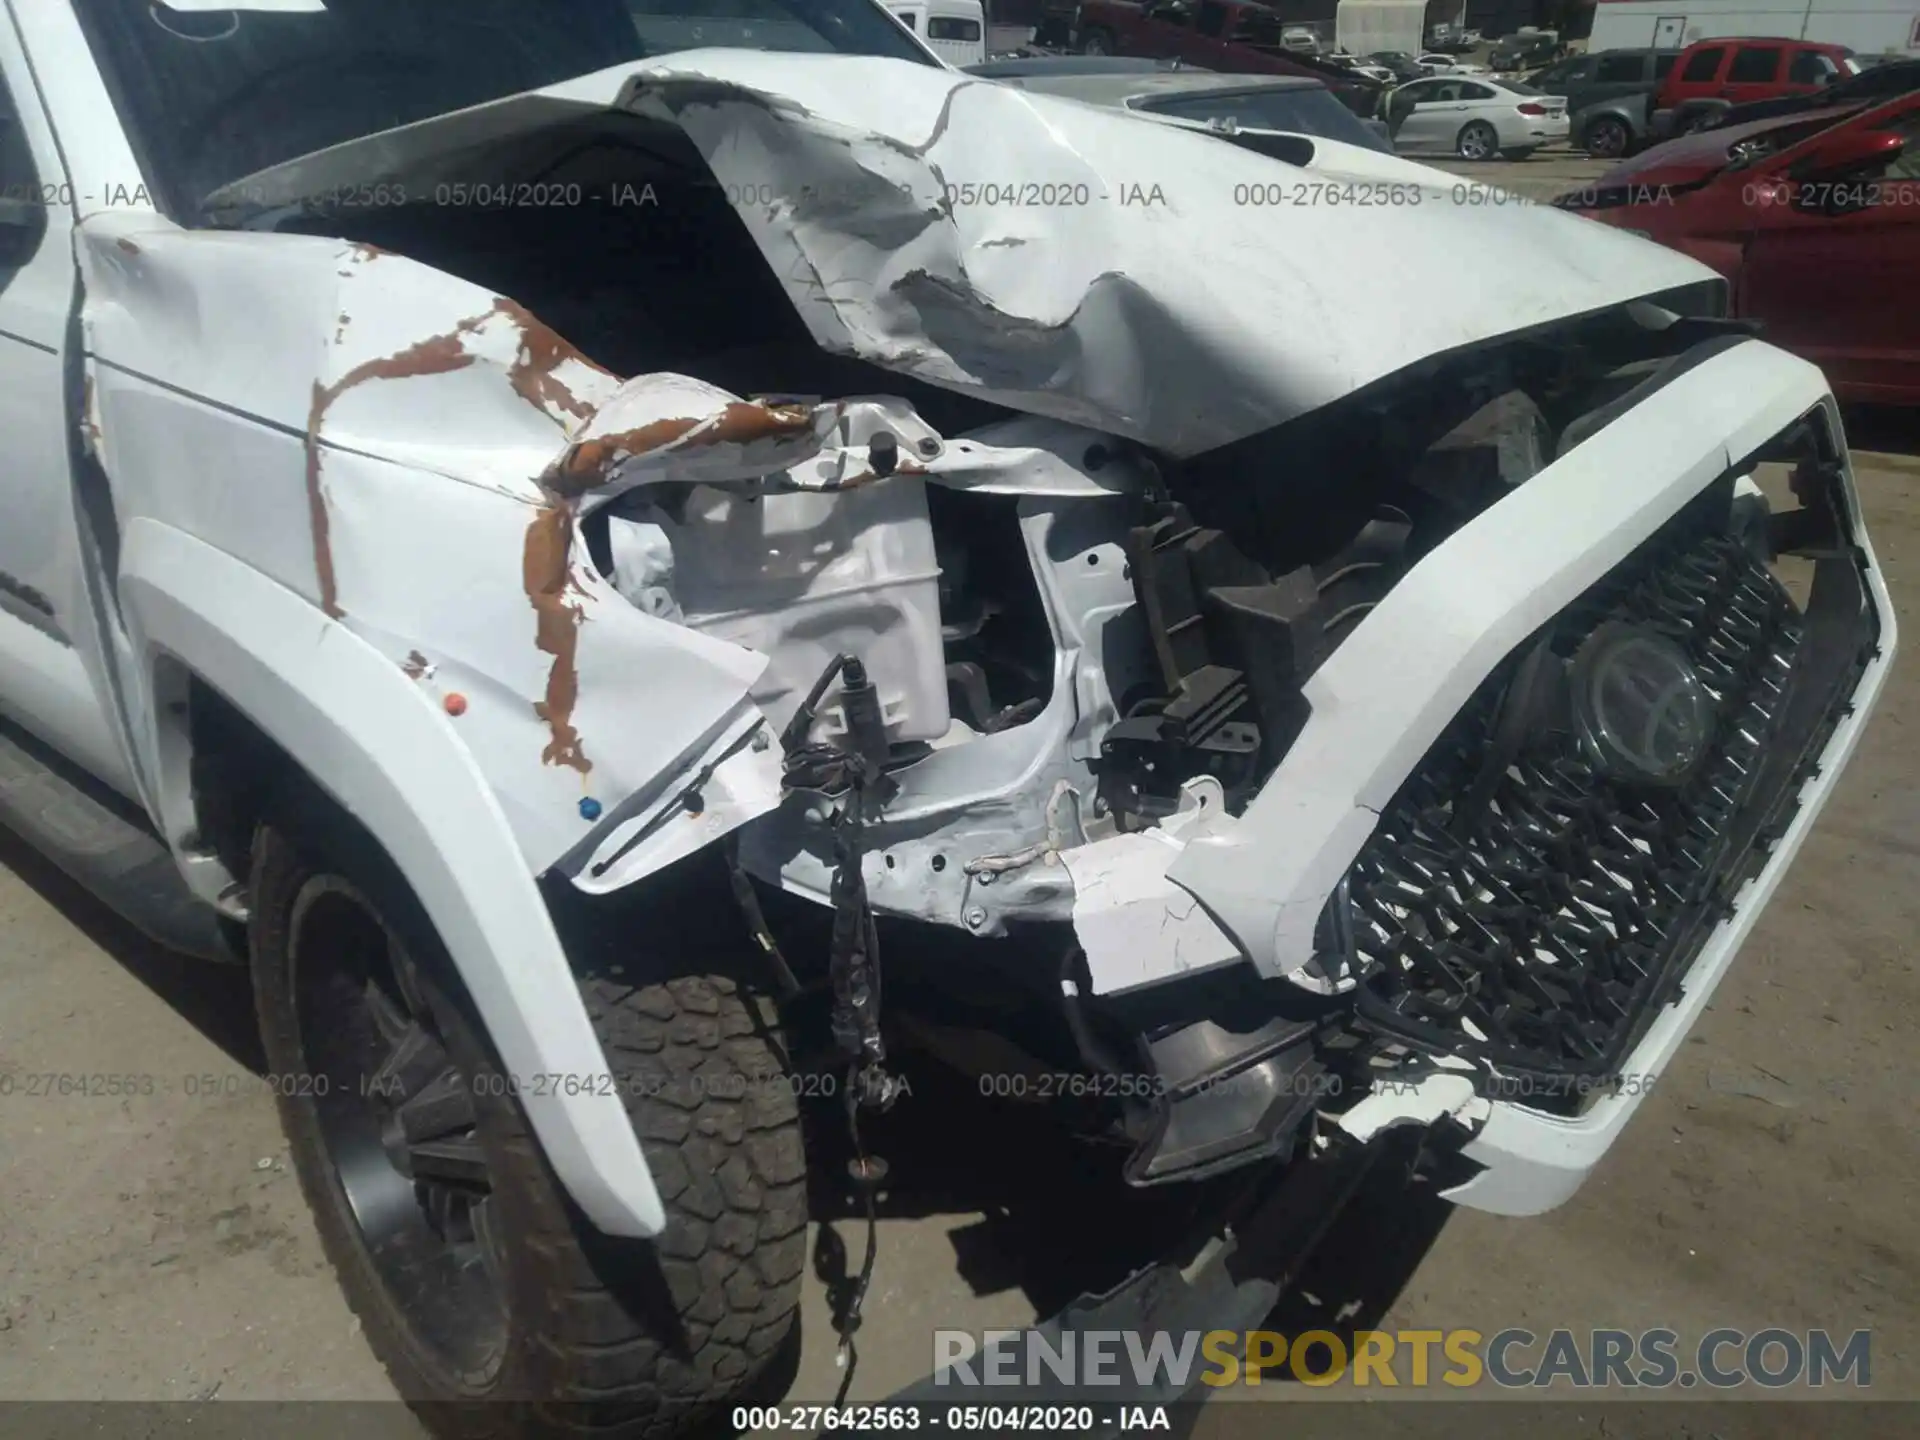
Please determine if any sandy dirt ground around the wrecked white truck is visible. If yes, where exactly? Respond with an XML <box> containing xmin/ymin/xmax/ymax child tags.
<box><xmin>0</xmin><ymin>156</ymin><xmax>1920</xmax><ymax>1434</ymax></box>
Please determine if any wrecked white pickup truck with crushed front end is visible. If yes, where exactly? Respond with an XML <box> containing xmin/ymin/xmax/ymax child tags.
<box><xmin>0</xmin><ymin>0</ymin><xmax>1893</xmax><ymax>1434</ymax></box>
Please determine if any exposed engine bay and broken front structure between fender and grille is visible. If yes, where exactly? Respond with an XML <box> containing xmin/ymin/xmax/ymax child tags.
<box><xmin>266</xmin><ymin>146</ymin><xmax>1766</xmax><ymax>1183</ymax></box>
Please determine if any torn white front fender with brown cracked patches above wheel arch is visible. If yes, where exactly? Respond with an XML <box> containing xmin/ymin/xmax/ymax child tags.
<box><xmin>81</xmin><ymin>215</ymin><xmax>798</xmax><ymax>877</ymax></box>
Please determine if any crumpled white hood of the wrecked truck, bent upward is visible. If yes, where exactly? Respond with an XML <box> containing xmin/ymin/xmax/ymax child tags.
<box><xmin>217</xmin><ymin>50</ymin><xmax>1713</xmax><ymax>455</ymax></box>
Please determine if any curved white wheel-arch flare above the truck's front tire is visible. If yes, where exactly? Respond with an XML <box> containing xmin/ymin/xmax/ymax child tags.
<box><xmin>119</xmin><ymin>516</ymin><xmax>666</xmax><ymax>1236</ymax></box>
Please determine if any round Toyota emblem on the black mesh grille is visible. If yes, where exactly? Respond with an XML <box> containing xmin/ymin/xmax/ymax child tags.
<box><xmin>1572</xmin><ymin>624</ymin><xmax>1715</xmax><ymax>785</ymax></box>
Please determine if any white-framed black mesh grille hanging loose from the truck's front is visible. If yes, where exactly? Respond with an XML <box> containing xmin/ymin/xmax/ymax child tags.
<box><xmin>1064</xmin><ymin>338</ymin><xmax>1895</xmax><ymax>1215</ymax></box>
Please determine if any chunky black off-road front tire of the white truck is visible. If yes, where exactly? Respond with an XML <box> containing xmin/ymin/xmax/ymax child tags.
<box><xmin>250</xmin><ymin>806</ymin><xmax>806</xmax><ymax>1440</ymax></box>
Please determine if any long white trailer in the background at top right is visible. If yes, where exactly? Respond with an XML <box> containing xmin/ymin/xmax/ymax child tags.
<box><xmin>1589</xmin><ymin>0</ymin><xmax>1920</xmax><ymax>56</ymax></box>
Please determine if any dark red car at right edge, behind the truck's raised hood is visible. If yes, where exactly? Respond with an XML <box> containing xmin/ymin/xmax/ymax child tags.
<box><xmin>1553</xmin><ymin>94</ymin><xmax>1920</xmax><ymax>405</ymax></box>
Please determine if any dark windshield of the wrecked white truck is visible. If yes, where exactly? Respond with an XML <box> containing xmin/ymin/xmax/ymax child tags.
<box><xmin>75</xmin><ymin>0</ymin><xmax>935</xmax><ymax>219</ymax></box>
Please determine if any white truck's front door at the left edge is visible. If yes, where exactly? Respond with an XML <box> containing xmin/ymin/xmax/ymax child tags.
<box><xmin>0</xmin><ymin>27</ymin><xmax>136</xmax><ymax>795</ymax></box>
